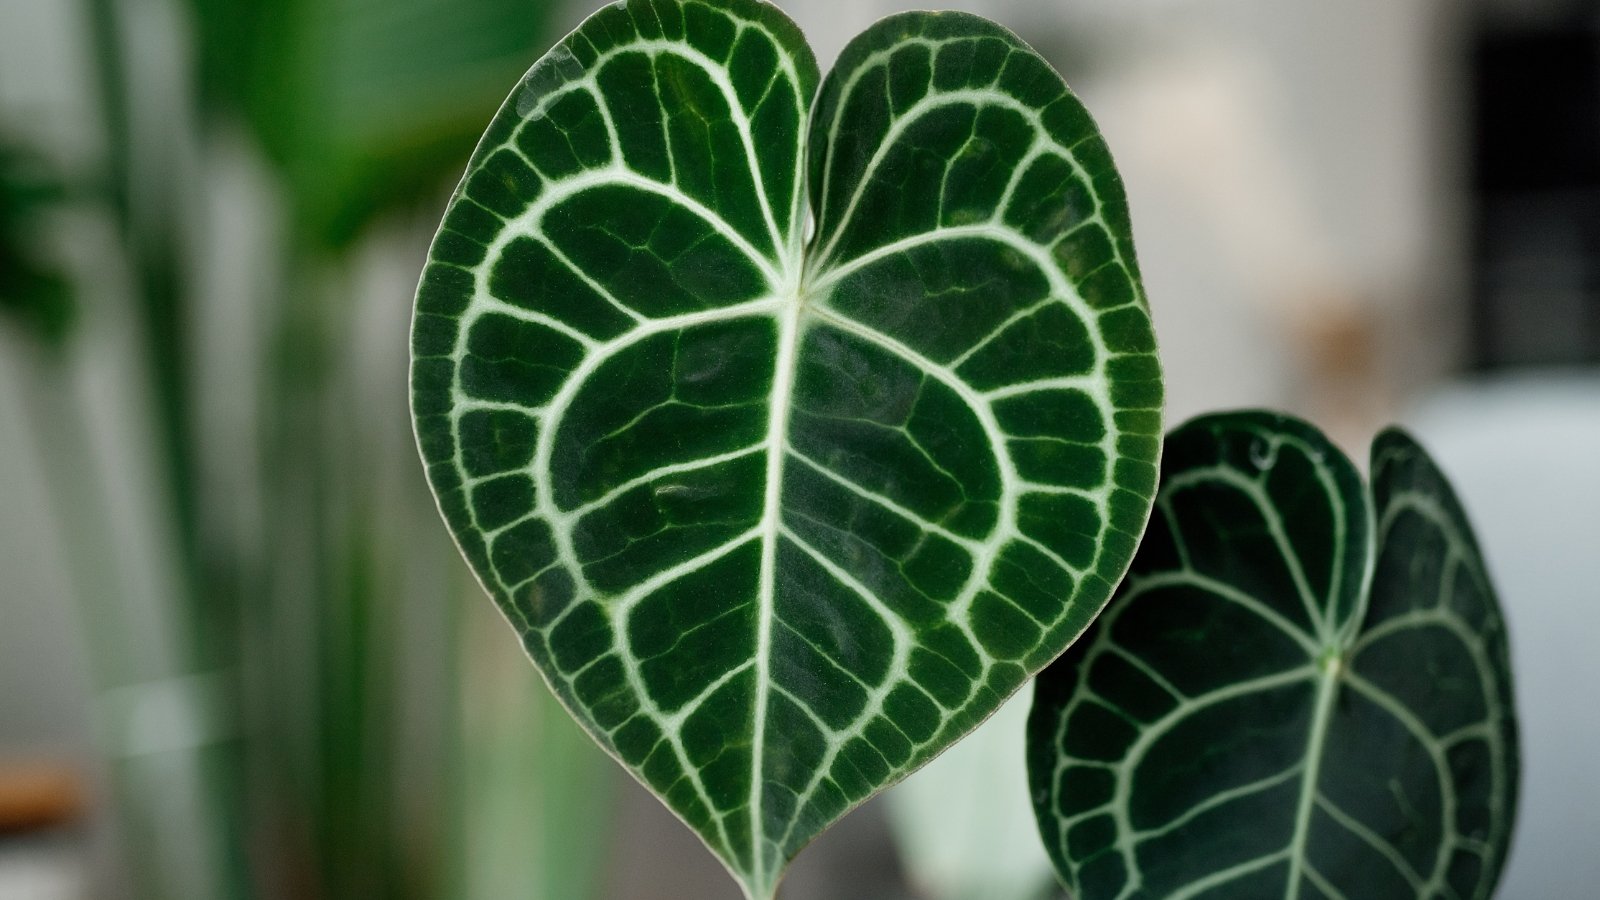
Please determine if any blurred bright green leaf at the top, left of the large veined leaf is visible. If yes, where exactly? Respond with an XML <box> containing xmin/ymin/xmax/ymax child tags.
<box><xmin>190</xmin><ymin>0</ymin><xmax>554</xmax><ymax>248</ymax></box>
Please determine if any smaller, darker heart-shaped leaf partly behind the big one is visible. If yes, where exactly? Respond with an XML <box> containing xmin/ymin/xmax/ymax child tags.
<box><xmin>1029</xmin><ymin>413</ymin><xmax>1518</xmax><ymax>900</ymax></box>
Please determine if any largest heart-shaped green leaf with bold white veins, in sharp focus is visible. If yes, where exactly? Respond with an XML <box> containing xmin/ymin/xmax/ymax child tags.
<box><xmin>413</xmin><ymin>0</ymin><xmax>1162</xmax><ymax>897</ymax></box>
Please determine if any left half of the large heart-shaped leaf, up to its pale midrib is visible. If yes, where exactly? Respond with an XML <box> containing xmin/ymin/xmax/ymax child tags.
<box><xmin>413</xmin><ymin>3</ymin><xmax>818</xmax><ymax>881</ymax></box>
